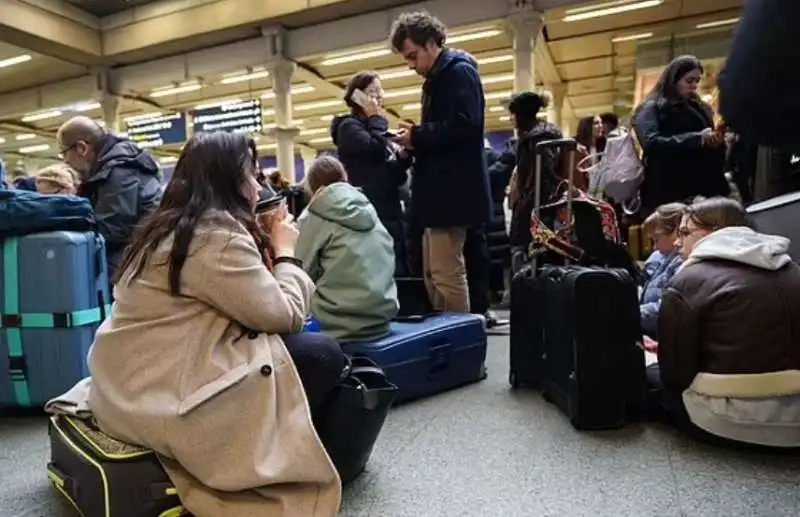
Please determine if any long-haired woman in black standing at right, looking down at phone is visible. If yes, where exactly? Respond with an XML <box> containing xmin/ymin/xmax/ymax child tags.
<box><xmin>633</xmin><ymin>52</ymin><xmax>730</xmax><ymax>217</ymax></box>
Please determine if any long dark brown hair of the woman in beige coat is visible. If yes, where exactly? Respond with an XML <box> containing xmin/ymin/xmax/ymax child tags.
<box><xmin>117</xmin><ymin>132</ymin><xmax>272</xmax><ymax>296</ymax></box>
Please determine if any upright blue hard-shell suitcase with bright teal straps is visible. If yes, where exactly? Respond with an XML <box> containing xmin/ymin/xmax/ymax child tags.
<box><xmin>0</xmin><ymin>232</ymin><xmax>110</xmax><ymax>407</ymax></box>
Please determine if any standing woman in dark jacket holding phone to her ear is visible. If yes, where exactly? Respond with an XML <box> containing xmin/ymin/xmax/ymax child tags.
<box><xmin>331</xmin><ymin>72</ymin><xmax>411</xmax><ymax>277</ymax></box>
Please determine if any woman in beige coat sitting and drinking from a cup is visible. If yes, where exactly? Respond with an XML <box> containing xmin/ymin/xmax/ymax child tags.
<box><xmin>89</xmin><ymin>133</ymin><xmax>345</xmax><ymax>517</ymax></box>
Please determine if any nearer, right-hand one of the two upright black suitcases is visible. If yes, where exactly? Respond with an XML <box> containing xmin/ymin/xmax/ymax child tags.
<box><xmin>539</xmin><ymin>266</ymin><xmax>645</xmax><ymax>430</ymax></box>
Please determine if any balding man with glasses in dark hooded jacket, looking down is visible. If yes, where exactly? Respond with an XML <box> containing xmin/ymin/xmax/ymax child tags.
<box><xmin>56</xmin><ymin>117</ymin><xmax>161</xmax><ymax>278</ymax></box>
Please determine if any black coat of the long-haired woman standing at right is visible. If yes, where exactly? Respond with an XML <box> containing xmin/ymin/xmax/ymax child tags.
<box><xmin>633</xmin><ymin>100</ymin><xmax>730</xmax><ymax>215</ymax></box>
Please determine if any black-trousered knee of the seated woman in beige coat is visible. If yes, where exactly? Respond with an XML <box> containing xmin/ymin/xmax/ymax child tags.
<box><xmin>282</xmin><ymin>332</ymin><xmax>347</xmax><ymax>413</ymax></box>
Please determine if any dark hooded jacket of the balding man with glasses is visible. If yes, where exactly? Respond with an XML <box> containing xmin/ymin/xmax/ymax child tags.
<box><xmin>79</xmin><ymin>134</ymin><xmax>162</xmax><ymax>277</ymax></box>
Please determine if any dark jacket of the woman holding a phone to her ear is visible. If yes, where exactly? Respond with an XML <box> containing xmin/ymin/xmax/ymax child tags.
<box><xmin>331</xmin><ymin>115</ymin><xmax>411</xmax><ymax>224</ymax></box>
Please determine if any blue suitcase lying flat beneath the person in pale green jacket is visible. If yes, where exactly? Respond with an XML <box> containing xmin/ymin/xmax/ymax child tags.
<box><xmin>343</xmin><ymin>313</ymin><xmax>487</xmax><ymax>404</ymax></box>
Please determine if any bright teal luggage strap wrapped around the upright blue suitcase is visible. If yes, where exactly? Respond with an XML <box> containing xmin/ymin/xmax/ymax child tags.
<box><xmin>0</xmin><ymin>237</ymin><xmax>111</xmax><ymax>407</ymax></box>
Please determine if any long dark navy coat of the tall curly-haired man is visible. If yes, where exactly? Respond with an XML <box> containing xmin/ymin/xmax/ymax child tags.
<box><xmin>411</xmin><ymin>49</ymin><xmax>491</xmax><ymax>228</ymax></box>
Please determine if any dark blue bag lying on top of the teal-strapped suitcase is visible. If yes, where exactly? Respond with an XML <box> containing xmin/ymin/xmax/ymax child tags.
<box><xmin>0</xmin><ymin>190</ymin><xmax>96</xmax><ymax>238</ymax></box>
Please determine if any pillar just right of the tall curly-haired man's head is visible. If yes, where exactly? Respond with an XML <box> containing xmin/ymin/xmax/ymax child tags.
<box><xmin>507</xmin><ymin>9</ymin><xmax>544</xmax><ymax>93</ymax></box>
